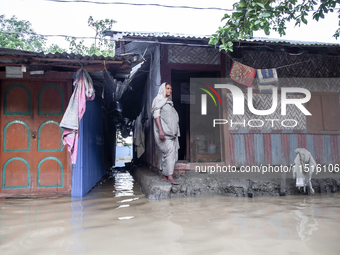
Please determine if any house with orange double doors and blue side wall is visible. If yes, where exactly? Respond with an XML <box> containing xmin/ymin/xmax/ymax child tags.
<box><xmin>0</xmin><ymin>48</ymin><xmax>143</xmax><ymax>197</ymax></box>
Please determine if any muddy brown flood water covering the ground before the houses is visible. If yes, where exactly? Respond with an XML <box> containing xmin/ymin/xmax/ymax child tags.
<box><xmin>0</xmin><ymin>168</ymin><xmax>340</xmax><ymax>254</ymax></box>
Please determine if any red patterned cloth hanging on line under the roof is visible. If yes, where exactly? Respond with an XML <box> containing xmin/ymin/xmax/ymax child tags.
<box><xmin>229</xmin><ymin>60</ymin><xmax>256</xmax><ymax>87</ymax></box>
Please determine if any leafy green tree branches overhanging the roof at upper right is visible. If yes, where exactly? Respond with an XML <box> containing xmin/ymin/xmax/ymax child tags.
<box><xmin>209</xmin><ymin>0</ymin><xmax>340</xmax><ymax>52</ymax></box>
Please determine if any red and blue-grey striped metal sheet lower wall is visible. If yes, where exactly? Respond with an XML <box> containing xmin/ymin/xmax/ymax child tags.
<box><xmin>229</xmin><ymin>134</ymin><xmax>340</xmax><ymax>166</ymax></box>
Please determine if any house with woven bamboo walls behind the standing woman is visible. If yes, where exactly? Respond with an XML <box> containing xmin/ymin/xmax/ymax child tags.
<box><xmin>106</xmin><ymin>31</ymin><xmax>340</xmax><ymax>177</ymax></box>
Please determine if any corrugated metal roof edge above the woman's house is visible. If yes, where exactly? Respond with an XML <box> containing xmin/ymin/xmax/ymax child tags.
<box><xmin>104</xmin><ymin>31</ymin><xmax>340</xmax><ymax>47</ymax></box>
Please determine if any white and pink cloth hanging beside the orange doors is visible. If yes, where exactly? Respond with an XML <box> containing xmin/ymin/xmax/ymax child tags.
<box><xmin>59</xmin><ymin>68</ymin><xmax>95</xmax><ymax>164</ymax></box>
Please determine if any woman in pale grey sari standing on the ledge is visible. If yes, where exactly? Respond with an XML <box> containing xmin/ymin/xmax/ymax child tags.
<box><xmin>152</xmin><ymin>83</ymin><xmax>180</xmax><ymax>184</ymax></box>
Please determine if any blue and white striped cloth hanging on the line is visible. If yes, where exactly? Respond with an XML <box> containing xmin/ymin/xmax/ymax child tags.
<box><xmin>256</xmin><ymin>68</ymin><xmax>279</xmax><ymax>93</ymax></box>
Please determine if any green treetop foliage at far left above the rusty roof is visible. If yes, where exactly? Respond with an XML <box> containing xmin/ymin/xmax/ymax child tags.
<box><xmin>0</xmin><ymin>15</ymin><xmax>46</xmax><ymax>52</ymax></box>
